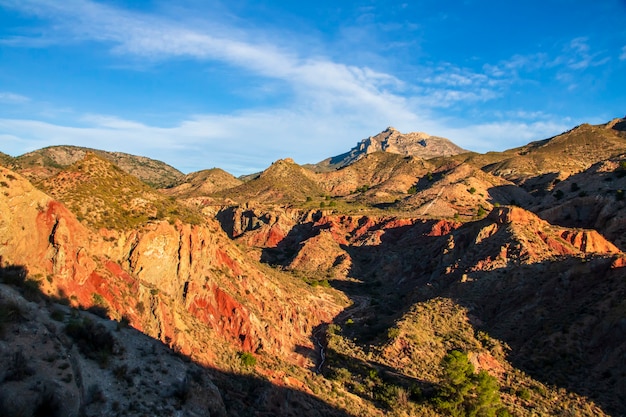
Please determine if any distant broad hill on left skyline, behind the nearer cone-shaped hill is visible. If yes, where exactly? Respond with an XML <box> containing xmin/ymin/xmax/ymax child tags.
<box><xmin>10</xmin><ymin>146</ymin><xmax>183</xmax><ymax>188</ymax></box>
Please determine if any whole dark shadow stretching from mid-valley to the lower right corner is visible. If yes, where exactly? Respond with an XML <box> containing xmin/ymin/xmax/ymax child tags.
<box><xmin>324</xmin><ymin>216</ymin><xmax>626</xmax><ymax>415</ymax></box>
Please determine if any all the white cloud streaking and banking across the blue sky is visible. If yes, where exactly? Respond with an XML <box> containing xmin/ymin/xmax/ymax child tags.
<box><xmin>0</xmin><ymin>0</ymin><xmax>584</xmax><ymax>174</ymax></box>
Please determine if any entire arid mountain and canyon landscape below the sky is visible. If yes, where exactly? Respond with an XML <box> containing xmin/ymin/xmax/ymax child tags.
<box><xmin>0</xmin><ymin>119</ymin><xmax>626</xmax><ymax>417</ymax></box>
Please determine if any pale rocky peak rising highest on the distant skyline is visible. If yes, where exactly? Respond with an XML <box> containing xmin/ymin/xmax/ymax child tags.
<box><xmin>312</xmin><ymin>127</ymin><xmax>467</xmax><ymax>171</ymax></box>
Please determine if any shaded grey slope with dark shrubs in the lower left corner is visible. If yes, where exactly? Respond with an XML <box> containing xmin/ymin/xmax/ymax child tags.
<box><xmin>0</xmin><ymin>266</ymin><xmax>351</xmax><ymax>417</ymax></box>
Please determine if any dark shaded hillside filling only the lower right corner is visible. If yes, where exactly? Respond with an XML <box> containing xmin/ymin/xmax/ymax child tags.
<box><xmin>442</xmin><ymin>256</ymin><xmax>626</xmax><ymax>415</ymax></box>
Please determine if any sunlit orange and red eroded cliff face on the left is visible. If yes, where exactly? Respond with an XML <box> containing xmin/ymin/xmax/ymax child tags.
<box><xmin>0</xmin><ymin>169</ymin><xmax>340</xmax><ymax>363</ymax></box>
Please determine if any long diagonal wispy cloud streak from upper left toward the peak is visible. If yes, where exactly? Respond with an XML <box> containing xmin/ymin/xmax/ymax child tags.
<box><xmin>4</xmin><ymin>0</ymin><xmax>410</xmax><ymax>119</ymax></box>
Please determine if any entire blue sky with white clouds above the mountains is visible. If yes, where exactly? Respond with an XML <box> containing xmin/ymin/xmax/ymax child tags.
<box><xmin>0</xmin><ymin>0</ymin><xmax>626</xmax><ymax>175</ymax></box>
